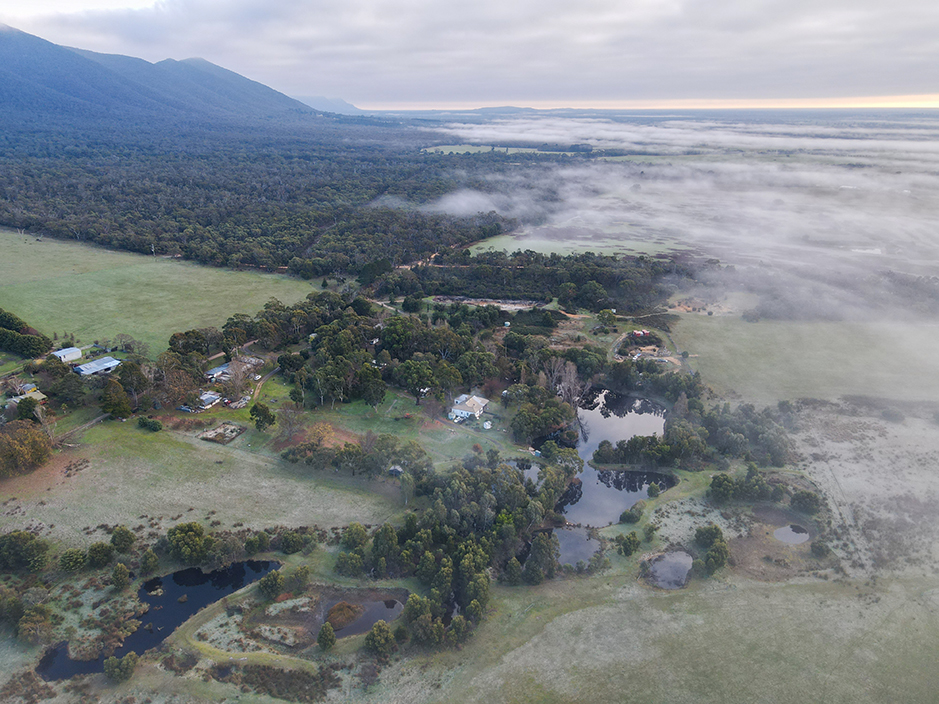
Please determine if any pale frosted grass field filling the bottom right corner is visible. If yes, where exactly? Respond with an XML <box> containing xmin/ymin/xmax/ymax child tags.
<box><xmin>433</xmin><ymin>576</ymin><xmax>939</xmax><ymax>704</ymax></box>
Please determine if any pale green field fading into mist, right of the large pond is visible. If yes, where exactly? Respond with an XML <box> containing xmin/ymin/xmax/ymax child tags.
<box><xmin>672</xmin><ymin>313</ymin><xmax>939</xmax><ymax>404</ymax></box>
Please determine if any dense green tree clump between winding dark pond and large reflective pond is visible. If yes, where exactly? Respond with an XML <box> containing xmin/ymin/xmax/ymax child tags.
<box><xmin>289</xmin><ymin>436</ymin><xmax>583</xmax><ymax>644</ymax></box>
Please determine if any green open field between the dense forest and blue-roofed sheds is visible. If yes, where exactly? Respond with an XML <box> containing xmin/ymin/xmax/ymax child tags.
<box><xmin>0</xmin><ymin>230</ymin><xmax>313</xmax><ymax>362</ymax></box>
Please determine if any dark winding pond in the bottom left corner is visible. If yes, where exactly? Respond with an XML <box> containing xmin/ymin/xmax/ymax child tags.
<box><xmin>36</xmin><ymin>560</ymin><xmax>280</xmax><ymax>681</ymax></box>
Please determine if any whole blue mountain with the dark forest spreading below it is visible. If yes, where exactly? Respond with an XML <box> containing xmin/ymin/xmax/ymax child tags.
<box><xmin>0</xmin><ymin>28</ymin><xmax>556</xmax><ymax>277</ymax></box>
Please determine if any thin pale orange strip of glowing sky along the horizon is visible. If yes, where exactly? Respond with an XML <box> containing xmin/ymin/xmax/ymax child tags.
<box><xmin>355</xmin><ymin>93</ymin><xmax>939</xmax><ymax>112</ymax></box>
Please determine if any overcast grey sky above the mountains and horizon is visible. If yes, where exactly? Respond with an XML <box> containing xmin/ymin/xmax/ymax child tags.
<box><xmin>0</xmin><ymin>0</ymin><xmax>939</xmax><ymax>109</ymax></box>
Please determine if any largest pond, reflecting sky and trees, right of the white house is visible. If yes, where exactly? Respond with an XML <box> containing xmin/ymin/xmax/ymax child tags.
<box><xmin>526</xmin><ymin>389</ymin><xmax>675</xmax><ymax>526</ymax></box>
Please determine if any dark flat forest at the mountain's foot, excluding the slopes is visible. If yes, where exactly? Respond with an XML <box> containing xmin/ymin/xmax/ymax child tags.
<box><xmin>0</xmin><ymin>117</ymin><xmax>592</xmax><ymax>277</ymax></box>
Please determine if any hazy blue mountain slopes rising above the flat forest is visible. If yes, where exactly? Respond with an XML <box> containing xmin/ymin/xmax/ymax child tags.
<box><xmin>0</xmin><ymin>25</ymin><xmax>334</xmax><ymax>122</ymax></box>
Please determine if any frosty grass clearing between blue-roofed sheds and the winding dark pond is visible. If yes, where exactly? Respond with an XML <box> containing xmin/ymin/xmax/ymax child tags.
<box><xmin>0</xmin><ymin>421</ymin><xmax>403</xmax><ymax>546</ymax></box>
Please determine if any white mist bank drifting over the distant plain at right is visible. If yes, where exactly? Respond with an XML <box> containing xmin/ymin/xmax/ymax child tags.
<box><xmin>437</xmin><ymin>113</ymin><xmax>939</xmax><ymax>328</ymax></box>
